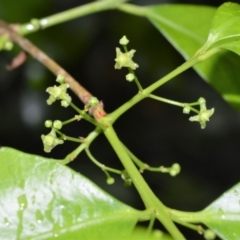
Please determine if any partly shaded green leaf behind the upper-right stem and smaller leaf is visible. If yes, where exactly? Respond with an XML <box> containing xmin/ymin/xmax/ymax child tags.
<box><xmin>146</xmin><ymin>4</ymin><xmax>240</xmax><ymax>110</ymax></box>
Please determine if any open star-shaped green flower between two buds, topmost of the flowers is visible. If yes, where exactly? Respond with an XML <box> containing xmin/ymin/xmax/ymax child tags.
<box><xmin>114</xmin><ymin>48</ymin><xmax>139</xmax><ymax>70</ymax></box>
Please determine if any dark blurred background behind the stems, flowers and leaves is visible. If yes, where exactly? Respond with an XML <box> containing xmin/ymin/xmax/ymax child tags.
<box><xmin>0</xmin><ymin>0</ymin><xmax>240</xmax><ymax>239</ymax></box>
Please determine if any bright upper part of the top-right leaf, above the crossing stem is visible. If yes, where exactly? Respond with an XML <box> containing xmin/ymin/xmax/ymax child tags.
<box><xmin>147</xmin><ymin>4</ymin><xmax>216</xmax><ymax>58</ymax></box>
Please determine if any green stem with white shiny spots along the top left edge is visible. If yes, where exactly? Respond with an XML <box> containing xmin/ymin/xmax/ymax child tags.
<box><xmin>18</xmin><ymin>0</ymin><xmax>127</xmax><ymax>35</ymax></box>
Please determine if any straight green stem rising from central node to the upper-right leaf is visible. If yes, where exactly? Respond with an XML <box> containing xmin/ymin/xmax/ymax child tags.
<box><xmin>109</xmin><ymin>57</ymin><xmax>199</xmax><ymax>122</ymax></box>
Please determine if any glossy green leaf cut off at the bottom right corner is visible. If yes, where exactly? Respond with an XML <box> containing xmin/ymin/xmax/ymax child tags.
<box><xmin>202</xmin><ymin>183</ymin><xmax>240</xmax><ymax>240</ymax></box>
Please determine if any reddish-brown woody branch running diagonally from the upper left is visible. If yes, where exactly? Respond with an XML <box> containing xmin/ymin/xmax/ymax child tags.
<box><xmin>0</xmin><ymin>20</ymin><xmax>106</xmax><ymax>120</ymax></box>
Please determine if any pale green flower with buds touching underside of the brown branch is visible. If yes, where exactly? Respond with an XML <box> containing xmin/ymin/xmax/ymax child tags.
<box><xmin>46</xmin><ymin>75</ymin><xmax>72</xmax><ymax>107</ymax></box>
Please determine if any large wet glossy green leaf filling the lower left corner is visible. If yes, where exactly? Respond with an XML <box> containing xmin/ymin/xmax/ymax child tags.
<box><xmin>0</xmin><ymin>147</ymin><xmax>141</xmax><ymax>240</ymax></box>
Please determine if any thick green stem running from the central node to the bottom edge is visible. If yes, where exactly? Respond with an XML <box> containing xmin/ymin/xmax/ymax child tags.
<box><xmin>104</xmin><ymin>127</ymin><xmax>185</xmax><ymax>240</ymax></box>
